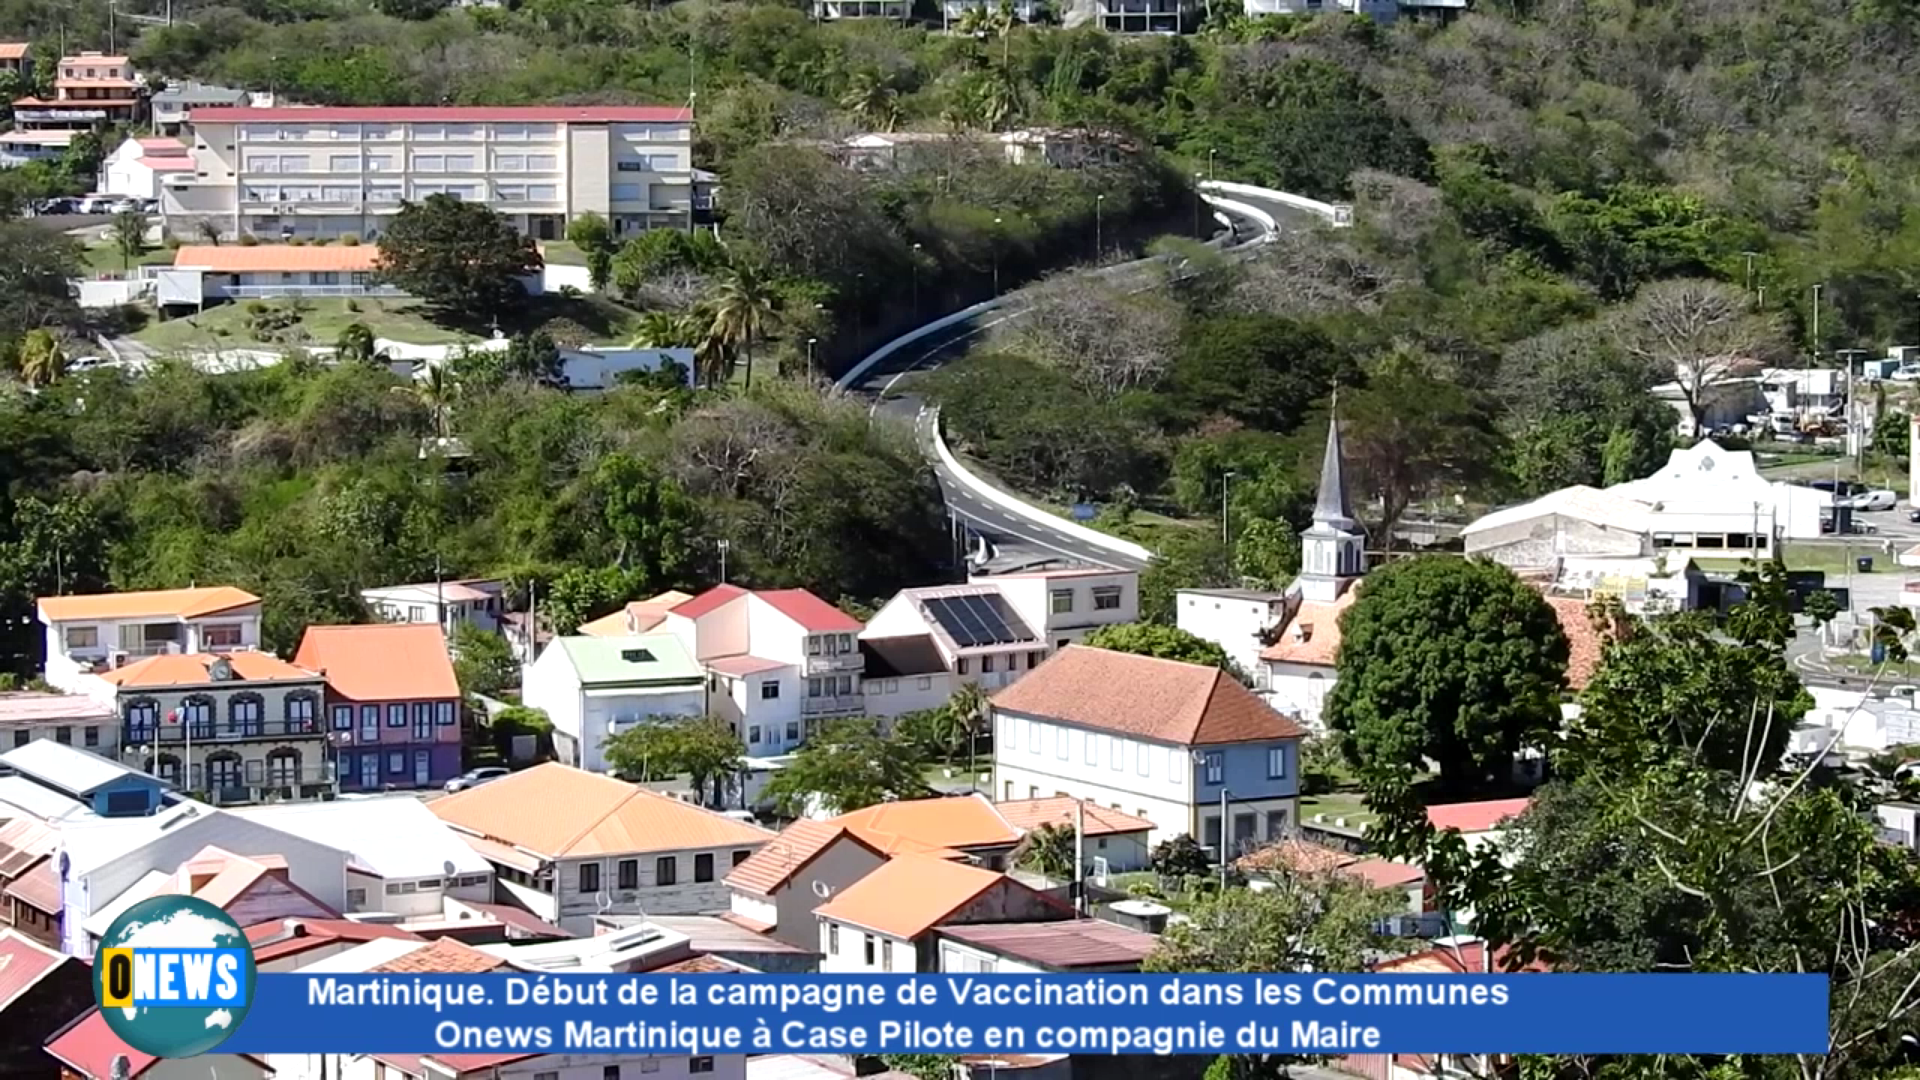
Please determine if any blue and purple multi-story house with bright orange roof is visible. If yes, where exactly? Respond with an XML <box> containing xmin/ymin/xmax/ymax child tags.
<box><xmin>294</xmin><ymin>623</ymin><xmax>461</xmax><ymax>792</ymax></box>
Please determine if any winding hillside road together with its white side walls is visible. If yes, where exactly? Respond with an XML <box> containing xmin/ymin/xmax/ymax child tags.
<box><xmin>839</xmin><ymin>184</ymin><xmax>1331</xmax><ymax>573</ymax></box>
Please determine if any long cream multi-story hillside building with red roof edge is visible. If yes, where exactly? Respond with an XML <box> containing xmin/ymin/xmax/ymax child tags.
<box><xmin>161</xmin><ymin>106</ymin><xmax>701</xmax><ymax>240</ymax></box>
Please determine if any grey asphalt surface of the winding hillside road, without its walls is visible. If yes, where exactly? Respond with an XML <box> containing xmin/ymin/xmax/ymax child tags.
<box><xmin>847</xmin><ymin>194</ymin><xmax>1319</xmax><ymax>573</ymax></box>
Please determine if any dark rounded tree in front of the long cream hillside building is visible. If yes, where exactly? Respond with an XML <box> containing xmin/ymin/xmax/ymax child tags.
<box><xmin>380</xmin><ymin>194</ymin><xmax>541</xmax><ymax>323</ymax></box>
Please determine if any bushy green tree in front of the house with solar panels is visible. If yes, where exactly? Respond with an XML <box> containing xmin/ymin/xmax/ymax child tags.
<box><xmin>766</xmin><ymin>717</ymin><xmax>929</xmax><ymax>817</ymax></box>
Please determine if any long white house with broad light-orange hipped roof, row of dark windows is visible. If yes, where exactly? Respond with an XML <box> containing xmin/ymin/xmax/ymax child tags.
<box><xmin>428</xmin><ymin>763</ymin><xmax>774</xmax><ymax>934</ymax></box>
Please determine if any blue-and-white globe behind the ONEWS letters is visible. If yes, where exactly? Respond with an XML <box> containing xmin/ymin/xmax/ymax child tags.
<box><xmin>94</xmin><ymin>896</ymin><xmax>255</xmax><ymax>1057</ymax></box>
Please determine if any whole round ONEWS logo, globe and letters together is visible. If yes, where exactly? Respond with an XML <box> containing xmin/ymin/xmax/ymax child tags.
<box><xmin>94</xmin><ymin>896</ymin><xmax>253</xmax><ymax>1057</ymax></box>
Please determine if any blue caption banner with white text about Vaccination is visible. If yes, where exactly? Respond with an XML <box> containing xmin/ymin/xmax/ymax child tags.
<box><xmin>221</xmin><ymin>974</ymin><xmax>1828</xmax><ymax>1055</ymax></box>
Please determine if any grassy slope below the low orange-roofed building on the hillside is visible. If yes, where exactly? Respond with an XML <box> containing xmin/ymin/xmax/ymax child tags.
<box><xmin>132</xmin><ymin>296</ymin><xmax>636</xmax><ymax>350</ymax></box>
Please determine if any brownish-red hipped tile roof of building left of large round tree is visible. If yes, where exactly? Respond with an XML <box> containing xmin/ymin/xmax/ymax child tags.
<box><xmin>993</xmin><ymin>646</ymin><xmax>1302</xmax><ymax>746</ymax></box>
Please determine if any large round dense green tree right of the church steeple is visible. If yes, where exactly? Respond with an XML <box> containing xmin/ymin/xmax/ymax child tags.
<box><xmin>1325</xmin><ymin>555</ymin><xmax>1567</xmax><ymax>796</ymax></box>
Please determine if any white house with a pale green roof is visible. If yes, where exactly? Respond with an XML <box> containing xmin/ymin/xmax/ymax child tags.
<box><xmin>520</xmin><ymin>634</ymin><xmax>710</xmax><ymax>773</ymax></box>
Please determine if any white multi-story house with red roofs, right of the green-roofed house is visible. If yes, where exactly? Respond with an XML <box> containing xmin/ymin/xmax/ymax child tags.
<box><xmin>660</xmin><ymin>584</ymin><xmax>866</xmax><ymax>757</ymax></box>
